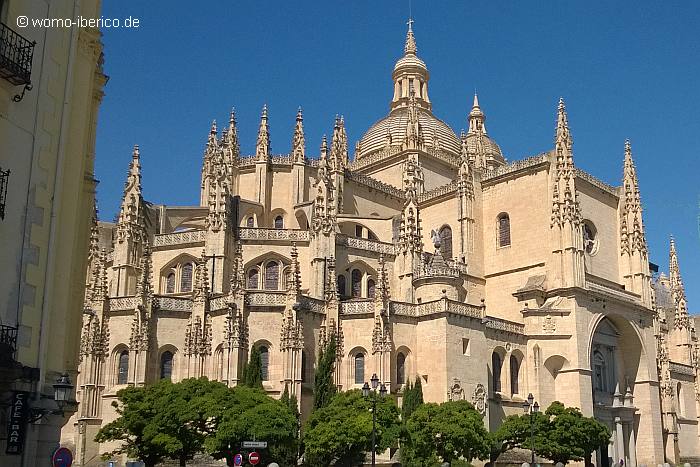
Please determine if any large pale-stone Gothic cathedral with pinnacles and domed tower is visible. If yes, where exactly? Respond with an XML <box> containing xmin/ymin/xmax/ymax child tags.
<box><xmin>63</xmin><ymin>24</ymin><xmax>700</xmax><ymax>466</ymax></box>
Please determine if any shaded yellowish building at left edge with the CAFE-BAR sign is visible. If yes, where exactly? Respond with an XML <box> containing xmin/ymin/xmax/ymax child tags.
<box><xmin>0</xmin><ymin>0</ymin><xmax>107</xmax><ymax>467</ymax></box>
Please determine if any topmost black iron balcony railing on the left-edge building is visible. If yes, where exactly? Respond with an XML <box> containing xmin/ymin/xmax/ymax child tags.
<box><xmin>0</xmin><ymin>22</ymin><xmax>36</xmax><ymax>86</ymax></box>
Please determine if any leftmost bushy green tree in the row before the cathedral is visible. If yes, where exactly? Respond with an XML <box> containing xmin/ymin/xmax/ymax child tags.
<box><xmin>95</xmin><ymin>378</ymin><xmax>227</xmax><ymax>466</ymax></box>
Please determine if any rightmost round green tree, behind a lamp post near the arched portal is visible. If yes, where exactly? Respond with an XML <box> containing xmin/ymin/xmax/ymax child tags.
<box><xmin>494</xmin><ymin>401</ymin><xmax>610</xmax><ymax>464</ymax></box>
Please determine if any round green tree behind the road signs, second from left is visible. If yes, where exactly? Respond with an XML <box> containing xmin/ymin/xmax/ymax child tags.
<box><xmin>205</xmin><ymin>386</ymin><xmax>297</xmax><ymax>465</ymax></box>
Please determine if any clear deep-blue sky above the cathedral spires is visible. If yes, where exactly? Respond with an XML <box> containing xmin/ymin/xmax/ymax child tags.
<box><xmin>96</xmin><ymin>0</ymin><xmax>700</xmax><ymax>311</ymax></box>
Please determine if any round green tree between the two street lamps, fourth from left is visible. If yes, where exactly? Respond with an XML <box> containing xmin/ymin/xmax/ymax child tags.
<box><xmin>401</xmin><ymin>401</ymin><xmax>491</xmax><ymax>467</ymax></box>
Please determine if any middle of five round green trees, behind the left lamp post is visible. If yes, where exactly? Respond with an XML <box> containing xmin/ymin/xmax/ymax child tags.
<box><xmin>303</xmin><ymin>389</ymin><xmax>401</xmax><ymax>467</ymax></box>
